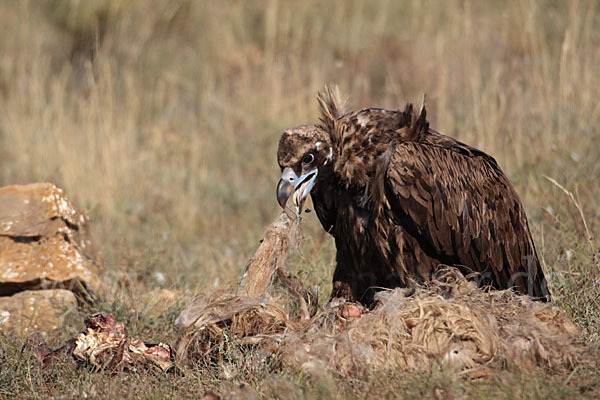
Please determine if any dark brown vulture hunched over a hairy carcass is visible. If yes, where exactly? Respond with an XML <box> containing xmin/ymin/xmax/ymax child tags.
<box><xmin>277</xmin><ymin>88</ymin><xmax>550</xmax><ymax>306</ymax></box>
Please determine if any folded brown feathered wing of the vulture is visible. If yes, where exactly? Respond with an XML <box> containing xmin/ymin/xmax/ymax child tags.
<box><xmin>383</xmin><ymin>136</ymin><xmax>543</xmax><ymax>297</ymax></box>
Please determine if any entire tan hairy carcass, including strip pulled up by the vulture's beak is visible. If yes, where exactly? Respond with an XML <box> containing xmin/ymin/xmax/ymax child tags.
<box><xmin>177</xmin><ymin>209</ymin><xmax>597</xmax><ymax>377</ymax></box>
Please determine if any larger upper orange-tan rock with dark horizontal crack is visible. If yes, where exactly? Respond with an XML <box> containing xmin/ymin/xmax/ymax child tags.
<box><xmin>0</xmin><ymin>183</ymin><xmax>100</xmax><ymax>298</ymax></box>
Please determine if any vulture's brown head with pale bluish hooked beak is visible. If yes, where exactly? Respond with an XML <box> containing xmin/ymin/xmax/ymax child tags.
<box><xmin>277</xmin><ymin>125</ymin><xmax>333</xmax><ymax>209</ymax></box>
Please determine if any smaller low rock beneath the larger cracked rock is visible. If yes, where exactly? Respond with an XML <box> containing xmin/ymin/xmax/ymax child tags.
<box><xmin>0</xmin><ymin>289</ymin><xmax>77</xmax><ymax>336</ymax></box>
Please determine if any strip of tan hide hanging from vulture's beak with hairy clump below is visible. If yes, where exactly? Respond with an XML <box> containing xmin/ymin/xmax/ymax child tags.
<box><xmin>175</xmin><ymin>210</ymin><xmax>300</xmax><ymax>362</ymax></box>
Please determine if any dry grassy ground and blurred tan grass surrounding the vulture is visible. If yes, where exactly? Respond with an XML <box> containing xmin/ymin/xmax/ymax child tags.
<box><xmin>0</xmin><ymin>0</ymin><xmax>600</xmax><ymax>398</ymax></box>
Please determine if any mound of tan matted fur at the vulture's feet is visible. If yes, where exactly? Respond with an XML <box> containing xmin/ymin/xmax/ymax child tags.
<box><xmin>281</xmin><ymin>268</ymin><xmax>596</xmax><ymax>377</ymax></box>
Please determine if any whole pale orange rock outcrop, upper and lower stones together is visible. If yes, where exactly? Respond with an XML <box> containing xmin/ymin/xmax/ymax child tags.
<box><xmin>0</xmin><ymin>183</ymin><xmax>100</xmax><ymax>334</ymax></box>
